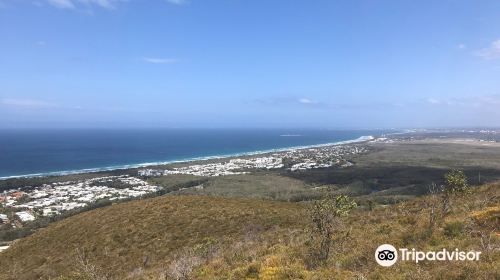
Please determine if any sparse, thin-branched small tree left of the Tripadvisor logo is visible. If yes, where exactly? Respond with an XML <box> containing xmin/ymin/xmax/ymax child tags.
<box><xmin>311</xmin><ymin>195</ymin><xmax>357</xmax><ymax>262</ymax></box>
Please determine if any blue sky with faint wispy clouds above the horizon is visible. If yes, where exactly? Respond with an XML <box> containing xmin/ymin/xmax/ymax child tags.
<box><xmin>0</xmin><ymin>0</ymin><xmax>500</xmax><ymax>128</ymax></box>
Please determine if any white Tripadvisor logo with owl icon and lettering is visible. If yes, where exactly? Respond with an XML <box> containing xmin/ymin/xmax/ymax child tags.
<box><xmin>375</xmin><ymin>244</ymin><xmax>481</xmax><ymax>267</ymax></box>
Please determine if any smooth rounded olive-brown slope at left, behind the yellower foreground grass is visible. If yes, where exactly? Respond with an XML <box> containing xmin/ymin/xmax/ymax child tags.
<box><xmin>0</xmin><ymin>196</ymin><xmax>302</xmax><ymax>279</ymax></box>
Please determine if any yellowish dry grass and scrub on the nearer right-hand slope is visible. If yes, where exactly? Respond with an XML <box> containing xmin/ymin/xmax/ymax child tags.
<box><xmin>186</xmin><ymin>184</ymin><xmax>500</xmax><ymax>280</ymax></box>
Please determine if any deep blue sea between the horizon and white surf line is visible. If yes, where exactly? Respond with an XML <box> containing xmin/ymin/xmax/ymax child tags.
<box><xmin>0</xmin><ymin>129</ymin><xmax>394</xmax><ymax>177</ymax></box>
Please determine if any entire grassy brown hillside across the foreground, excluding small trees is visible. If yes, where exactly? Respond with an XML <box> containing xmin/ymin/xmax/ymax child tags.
<box><xmin>0</xmin><ymin>184</ymin><xmax>500</xmax><ymax>280</ymax></box>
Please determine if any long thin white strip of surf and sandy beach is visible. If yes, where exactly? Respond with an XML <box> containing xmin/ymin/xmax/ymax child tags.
<box><xmin>0</xmin><ymin>135</ymin><xmax>378</xmax><ymax>181</ymax></box>
